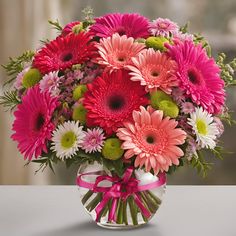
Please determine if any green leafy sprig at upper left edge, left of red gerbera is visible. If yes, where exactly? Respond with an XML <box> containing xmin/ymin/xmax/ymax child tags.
<box><xmin>2</xmin><ymin>51</ymin><xmax>34</xmax><ymax>86</ymax></box>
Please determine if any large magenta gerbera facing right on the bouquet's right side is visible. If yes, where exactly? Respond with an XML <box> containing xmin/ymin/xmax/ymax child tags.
<box><xmin>166</xmin><ymin>41</ymin><xmax>225</xmax><ymax>114</ymax></box>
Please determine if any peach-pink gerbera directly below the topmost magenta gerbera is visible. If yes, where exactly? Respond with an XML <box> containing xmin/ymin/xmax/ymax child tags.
<box><xmin>97</xmin><ymin>34</ymin><xmax>145</xmax><ymax>71</ymax></box>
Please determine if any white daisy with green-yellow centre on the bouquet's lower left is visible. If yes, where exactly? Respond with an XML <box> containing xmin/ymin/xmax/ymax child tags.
<box><xmin>51</xmin><ymin>121</ymin><xmax>85</xmax><ymax>160</ymax></box>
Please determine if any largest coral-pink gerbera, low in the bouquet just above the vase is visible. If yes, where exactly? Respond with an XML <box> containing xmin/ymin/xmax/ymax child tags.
<box><xmin>117</xmin><ymin>106</ymin><xmax>186</xmax><ymax>174</ymax></box>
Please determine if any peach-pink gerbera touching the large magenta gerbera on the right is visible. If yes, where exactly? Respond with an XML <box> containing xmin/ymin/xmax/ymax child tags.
<box><xmin>127</xmin><ymin>48</ymin><xmax>178</xmax><ymax>94</ymax></box>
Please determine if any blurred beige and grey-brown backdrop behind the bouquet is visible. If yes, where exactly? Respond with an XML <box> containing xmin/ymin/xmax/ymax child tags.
<box><xmin>0</xmin><ymin>0</ymin><xmax>236</xmax><ymax>184</ymax></box>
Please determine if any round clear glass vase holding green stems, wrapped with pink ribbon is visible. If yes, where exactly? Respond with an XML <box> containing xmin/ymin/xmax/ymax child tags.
<box><xmin>77</xmin><ymin>162</ymin><xmax>166</xmax><ymax>229</ymax></box>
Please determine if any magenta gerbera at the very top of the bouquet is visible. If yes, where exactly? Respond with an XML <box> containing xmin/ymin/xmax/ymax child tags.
<box><xmin>90</xmin><ymin>13</ymin><xmax>149</xmax><ymax>39</ymax></box>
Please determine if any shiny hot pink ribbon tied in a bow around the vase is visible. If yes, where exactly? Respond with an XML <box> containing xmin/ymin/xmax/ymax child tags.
<box><xmin>77</xmin><ymin>167</ymin><xmax>166</xmax><ymax>221</ymax></box>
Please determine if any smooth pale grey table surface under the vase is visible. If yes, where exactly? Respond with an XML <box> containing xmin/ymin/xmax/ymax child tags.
<box><xmin>0</xmin><ymin>186</ymin><xmax>236</xmax><ymax>236</ymax></box>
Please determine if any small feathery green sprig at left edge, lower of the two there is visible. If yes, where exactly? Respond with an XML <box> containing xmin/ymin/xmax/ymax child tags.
<box><xmin>0</xmin><ymin>91</ymin><xmax>20</xmax><ymax>111</ymax></box>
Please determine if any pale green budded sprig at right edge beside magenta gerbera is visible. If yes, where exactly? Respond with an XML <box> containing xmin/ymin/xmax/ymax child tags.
<box><xmin>216</xmin><ymin>53</ymin><xmax>236</xmax><ymax>87</ymax></box>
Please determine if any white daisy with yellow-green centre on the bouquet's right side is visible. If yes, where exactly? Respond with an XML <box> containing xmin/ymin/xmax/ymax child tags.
<box><xmin>188</xmin><ymin>107</ymin><xmax>218</xmax><ymax>149</ymax></box>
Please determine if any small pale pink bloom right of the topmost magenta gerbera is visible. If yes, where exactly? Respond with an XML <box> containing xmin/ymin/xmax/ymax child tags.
<box><xmin>149</xmin><ymin>18</ymin><xmax>179</xmax><ymax>37</ymax></box>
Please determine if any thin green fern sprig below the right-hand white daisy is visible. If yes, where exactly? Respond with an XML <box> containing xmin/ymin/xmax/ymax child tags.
<box><xmin>190</xmin><ymin>151</ymin><xmax>213</xmax><ymax>178</ymax></box>
